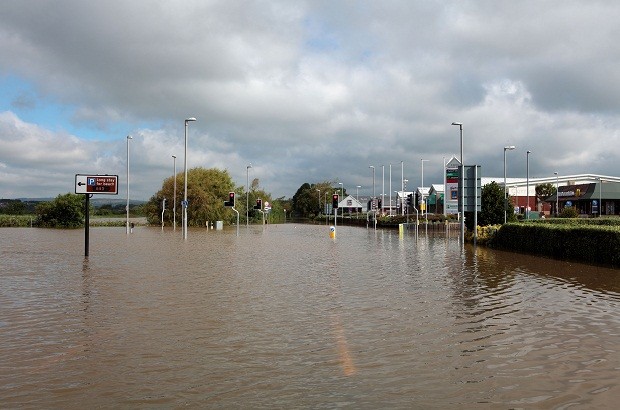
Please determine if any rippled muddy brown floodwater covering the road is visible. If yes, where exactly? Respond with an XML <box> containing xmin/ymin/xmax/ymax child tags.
<box><xmin>0</xmin><ymin>224</ymin><xmax>620</xmax><ymax>409</ymax></box>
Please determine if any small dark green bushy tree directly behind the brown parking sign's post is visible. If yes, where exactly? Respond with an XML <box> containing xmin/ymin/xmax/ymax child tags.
<box><xmin>35</xmin><ymin>193</ymin><xmax>84</xmax><ymax>228</ymax></box>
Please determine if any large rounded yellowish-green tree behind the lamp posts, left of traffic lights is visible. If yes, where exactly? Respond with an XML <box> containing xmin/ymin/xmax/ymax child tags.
<box><xmin>144</xmin><ymin>167</ymin><xmax>239</xmax><ymax>226</ymax></box>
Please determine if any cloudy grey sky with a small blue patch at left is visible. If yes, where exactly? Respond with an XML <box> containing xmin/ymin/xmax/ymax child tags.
<box><xmin>0</xmin><ymin>0</ymin><xmax>620</xmax><ymax>200</ymax></box>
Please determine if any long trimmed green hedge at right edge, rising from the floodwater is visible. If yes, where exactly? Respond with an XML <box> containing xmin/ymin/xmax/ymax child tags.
<box><xmin>490</xmin><ymin>223</ymin><xmax>620</xmax><ymax>267</ymax></box>
